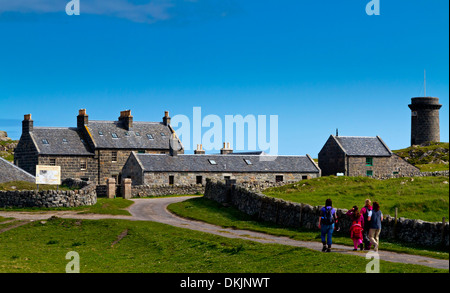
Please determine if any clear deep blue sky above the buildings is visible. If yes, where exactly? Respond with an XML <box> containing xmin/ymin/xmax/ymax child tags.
<box><xmin>0</xmin><ymin>0</ymin><xmax>449</xmax><ymax>157</ymax></box>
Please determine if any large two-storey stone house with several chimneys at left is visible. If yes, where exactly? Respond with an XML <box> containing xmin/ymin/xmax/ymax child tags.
<box><xmin>14</xmin><ymin>109</ymin><xmax>183</xmax><ymax>185</ymax></box>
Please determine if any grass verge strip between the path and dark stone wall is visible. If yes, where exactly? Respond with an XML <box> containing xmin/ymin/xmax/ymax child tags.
<box><xmin>168</xmin><ymin>198</ymin><xmax>449</xmax><ymax>259</ymax></box>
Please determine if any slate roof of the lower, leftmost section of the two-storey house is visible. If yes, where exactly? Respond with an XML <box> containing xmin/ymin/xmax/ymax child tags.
<box><xmin>30</xmin><ymin>127</ymin><xmax>94</xmax><ymax>156</ymax></box>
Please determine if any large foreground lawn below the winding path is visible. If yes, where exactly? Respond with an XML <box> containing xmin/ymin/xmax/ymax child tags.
<box><xmin>0</xmin><ymin>218</ymin><xmax>448</xmax><ymax>273</ymax></box>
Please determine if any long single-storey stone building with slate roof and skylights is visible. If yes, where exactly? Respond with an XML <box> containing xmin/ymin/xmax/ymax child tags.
<box><xmin>122</xmin><ymin>140</ymin><xmax>321</xmax><ymax>186</ymax></box>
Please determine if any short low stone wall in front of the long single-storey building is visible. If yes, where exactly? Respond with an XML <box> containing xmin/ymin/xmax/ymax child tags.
<box><xmin>131</xmin><ymin>184</ymin><xmax>205</xmax><ymax>197</ymax></box>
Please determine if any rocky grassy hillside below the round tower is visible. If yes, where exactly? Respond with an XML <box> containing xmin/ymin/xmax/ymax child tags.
<box><xmin>393</xmin><ymin>142</ymin><xmax>449</xmax><ymax>172</ymax></box>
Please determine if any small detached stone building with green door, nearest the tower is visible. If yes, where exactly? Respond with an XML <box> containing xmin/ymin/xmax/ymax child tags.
<box><xmin>318</xmin><ymin>135</ymin><xmax>420</xmax><ymax>178</ymax></box>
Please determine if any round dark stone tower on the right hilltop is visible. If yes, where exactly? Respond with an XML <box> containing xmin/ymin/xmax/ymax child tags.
<box><xmin>408</xmin><ymin>97</ymin><xmax>442</xmax><ymax>145</ymax></box>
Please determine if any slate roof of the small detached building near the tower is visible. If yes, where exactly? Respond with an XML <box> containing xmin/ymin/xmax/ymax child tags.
<box><xmin>333</xmin><ymin>136</ymin><xmax>392</xmax><ymax>157</ymax></box>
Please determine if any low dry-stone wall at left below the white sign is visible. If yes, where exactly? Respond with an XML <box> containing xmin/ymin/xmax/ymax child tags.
<box><xmin>0</xmin><ymin>184</ymin><xmax>97</xmax><ymax>208</ymax></box>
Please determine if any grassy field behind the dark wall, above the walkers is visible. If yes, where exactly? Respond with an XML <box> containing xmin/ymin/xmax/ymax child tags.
<box><xmin>264</xmin><ymin>176</ymin><xmax>449</xmax><ymax>222</ymax></box>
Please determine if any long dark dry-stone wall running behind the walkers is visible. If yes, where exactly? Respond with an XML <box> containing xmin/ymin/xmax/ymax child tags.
<box><xmin>204</xmin><ymin>180</ymin><xmax>449</xmax><ymax>247</ymax></box>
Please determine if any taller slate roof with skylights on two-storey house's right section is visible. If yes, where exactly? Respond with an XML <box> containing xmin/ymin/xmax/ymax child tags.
<box><xmin>87</xmin><ymin>120</ymin><xmax>176</xmax><ymax>149</ymax></box>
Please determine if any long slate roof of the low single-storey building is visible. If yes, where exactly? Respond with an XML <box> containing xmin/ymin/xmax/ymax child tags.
<box><xmin>133</xmin><ymin>152</ymin><xmax>319</xmax><ymax>173</ymax></box>
